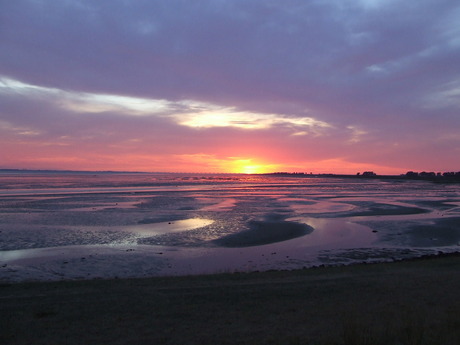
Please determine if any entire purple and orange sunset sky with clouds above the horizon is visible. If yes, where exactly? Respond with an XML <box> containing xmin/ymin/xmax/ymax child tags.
<box><xmin>0</xmin><ymin>0</ymin><xmax>460</xmax><ymax>174</ymax></box>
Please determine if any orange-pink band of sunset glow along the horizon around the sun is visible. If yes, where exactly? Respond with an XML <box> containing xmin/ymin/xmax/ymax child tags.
<box><xmin>0</xmin><ymin>138</ymin><xmax>410</xmax><ymax>175</ymax></box>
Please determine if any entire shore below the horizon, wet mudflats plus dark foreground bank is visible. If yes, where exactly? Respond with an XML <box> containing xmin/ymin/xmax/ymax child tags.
<box><xmin>0</xmin><ymin>172</ymin><xmax>460</xmax><ymax>345</ymax></box>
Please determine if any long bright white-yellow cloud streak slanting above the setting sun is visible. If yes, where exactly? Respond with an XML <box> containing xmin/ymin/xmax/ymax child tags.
<box><xmin>0</xmin><ymin>78</ymin><xmax>331</xmax><ymax>135</ymax></box>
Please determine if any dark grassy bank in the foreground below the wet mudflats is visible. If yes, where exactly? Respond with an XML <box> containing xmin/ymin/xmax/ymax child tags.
<box><xmin>0</xmin><ymin>255</ymin><xmax>460</xmax><ymax>345</ymax></box>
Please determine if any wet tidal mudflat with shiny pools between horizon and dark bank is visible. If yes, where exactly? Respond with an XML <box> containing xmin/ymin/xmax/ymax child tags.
<box><xmin>0</xmin><ymin>172</ymin><xmax>460</xmax><ymax>283</ymax></box>
